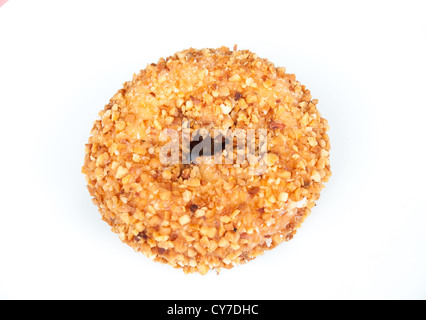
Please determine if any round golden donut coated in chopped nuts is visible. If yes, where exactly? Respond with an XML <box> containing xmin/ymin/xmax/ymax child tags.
<box><xmin>83</xmin><ymin>47</ymin><xmax>331</xmax><ymax>274</ymax></box>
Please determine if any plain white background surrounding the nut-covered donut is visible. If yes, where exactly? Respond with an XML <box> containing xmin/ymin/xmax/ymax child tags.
<box><xmin>0</xmin><ymin>0</ymin><xmax>426</xmax><ymax>299</ymax></box>
